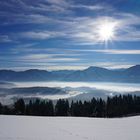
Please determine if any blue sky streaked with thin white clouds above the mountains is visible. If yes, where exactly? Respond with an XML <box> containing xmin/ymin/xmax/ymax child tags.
<box><xmin>0</xmin><ymin>0</ymin><xmax>140</xmax><ymax>70</ymax></box>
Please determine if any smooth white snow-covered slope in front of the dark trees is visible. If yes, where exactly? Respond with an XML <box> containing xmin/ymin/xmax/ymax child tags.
<box><xmin>0</xmin><ymin>115</ymin><xmax>140</xmax><ymax>140</ymax></box>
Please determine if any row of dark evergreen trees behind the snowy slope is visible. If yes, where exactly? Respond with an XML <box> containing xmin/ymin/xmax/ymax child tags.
<box><xmin>0</xmin><ymin>95</ymin><xmax>140</xmax><ymax>117</ymax></box>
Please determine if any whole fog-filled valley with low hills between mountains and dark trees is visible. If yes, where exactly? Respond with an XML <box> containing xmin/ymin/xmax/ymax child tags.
<box><xmin>0</xmin><ymin>81</ymin><xmax>140</xmax><ymax>104</ymax></box>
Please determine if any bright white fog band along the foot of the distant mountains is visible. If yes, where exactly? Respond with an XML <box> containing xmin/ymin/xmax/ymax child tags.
<box><xmin>13</xmin><ymin>81</ymin><xmax>140</xmax><ymax>93</ymax></box>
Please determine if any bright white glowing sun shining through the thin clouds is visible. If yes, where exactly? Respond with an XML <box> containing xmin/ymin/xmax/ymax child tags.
<box><xmin>97</xmin><ymin>21</ymin><xmax>116</xmax><ymax>42</ymax></box>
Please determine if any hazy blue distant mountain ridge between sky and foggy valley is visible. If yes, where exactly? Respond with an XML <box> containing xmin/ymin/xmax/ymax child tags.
<box><xmin>0</xmin><ymin>65</ymin><xmax>140</xmax><ymax>83</ymax></box>
